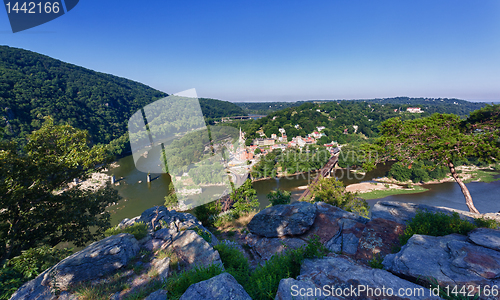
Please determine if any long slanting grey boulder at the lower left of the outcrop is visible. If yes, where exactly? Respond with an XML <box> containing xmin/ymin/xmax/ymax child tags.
<box><xmin>11</xmin><ymin>233</ymin><xmax>139</xmax><ymax>299</ymax></box>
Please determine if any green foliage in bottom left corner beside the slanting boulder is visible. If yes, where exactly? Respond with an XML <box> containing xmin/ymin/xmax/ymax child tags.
<box><xmin>0</xmin><ymin>246</ymin><xmax>73</xmax><ymax>300</ymax></box>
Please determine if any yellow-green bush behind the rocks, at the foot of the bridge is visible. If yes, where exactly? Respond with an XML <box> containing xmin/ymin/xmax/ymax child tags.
<box><xmin>307</xmin><ymin>178</ymin><xmax>369</xmax><ymax>217</ymax></box>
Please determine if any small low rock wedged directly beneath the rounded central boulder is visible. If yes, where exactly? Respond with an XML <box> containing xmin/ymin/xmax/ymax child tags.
<box><xmin>245</xmin><ymin>233</ymin><xmax>307</xmax><ymax>260</ymax></box>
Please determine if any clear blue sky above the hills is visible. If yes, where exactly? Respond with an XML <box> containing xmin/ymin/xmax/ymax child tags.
<box><xmin>0</xmin><ymin>0</ymin><xmax>500</xmax><ymax>101</ymax></box>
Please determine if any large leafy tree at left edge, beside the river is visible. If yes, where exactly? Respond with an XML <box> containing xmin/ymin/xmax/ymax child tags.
<box><xmin>0</xmin><ymin>118</ymin><xmax>119</xmax><ymax>261</ymax></box>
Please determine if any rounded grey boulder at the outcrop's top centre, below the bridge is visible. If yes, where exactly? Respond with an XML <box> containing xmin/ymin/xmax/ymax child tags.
<box><xmin>247</xmin><ymin>202</ymin><xmax>316</xmax><ymax>237</ymax></box>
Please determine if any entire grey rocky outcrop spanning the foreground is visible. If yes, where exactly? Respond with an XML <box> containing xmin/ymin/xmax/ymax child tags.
<box><xmin>12</xmin><ymin>202</ymin><xmax>500</xmax><ymax>300</ymax></box>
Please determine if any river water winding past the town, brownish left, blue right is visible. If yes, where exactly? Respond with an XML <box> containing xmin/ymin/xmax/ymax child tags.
<box><xmin>108</xmin><ymin>156</ymin><xmax>500</xmax><ymax>225</ymax></box>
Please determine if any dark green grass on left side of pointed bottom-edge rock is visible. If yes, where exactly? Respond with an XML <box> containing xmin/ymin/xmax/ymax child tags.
<box><xmin>163</xmin><ymin>264</ymin><xmax>224</xmax><ymax>300</ymax></box>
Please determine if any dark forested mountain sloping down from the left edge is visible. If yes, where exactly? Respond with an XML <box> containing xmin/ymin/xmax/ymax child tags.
<box><xmin>0</xmin><ymin>46</ymin><xmax>245</xmax><ymax>152</ymax></box>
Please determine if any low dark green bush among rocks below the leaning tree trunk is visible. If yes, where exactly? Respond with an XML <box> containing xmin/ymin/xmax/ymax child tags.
<box><xmin>400</xmin><ymin>211</ymin><xmax>477</xmax><ymax>245</ymax></box>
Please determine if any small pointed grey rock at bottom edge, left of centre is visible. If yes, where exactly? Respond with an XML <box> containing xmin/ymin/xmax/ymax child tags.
<box><xmin>180</xmin><ymin>273</ymin><xmax>252</xmax><ymax>300</ymax></box>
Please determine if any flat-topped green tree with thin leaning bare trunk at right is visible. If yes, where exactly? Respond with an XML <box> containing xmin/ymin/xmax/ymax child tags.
<box><xmin>364</xmin><ymin>114</ymin><xmax>500</xmax><ymax>213</ymax></box>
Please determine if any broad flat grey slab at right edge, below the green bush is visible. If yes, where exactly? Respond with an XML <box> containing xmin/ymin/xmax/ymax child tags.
<box><xmin>383</xmin><ymin>234</ymin><xmax>500</xmax><ymax>299</ymax></box>
